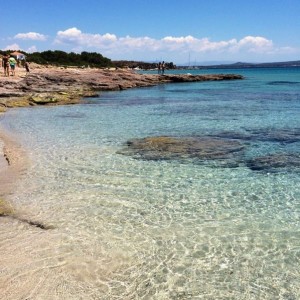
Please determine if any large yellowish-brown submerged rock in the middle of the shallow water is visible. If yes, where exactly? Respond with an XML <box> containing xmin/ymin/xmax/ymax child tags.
<box><xmin>119</xmin><ymin>136</ymin><xmax>244</xmax><ymax>164</ymax></box>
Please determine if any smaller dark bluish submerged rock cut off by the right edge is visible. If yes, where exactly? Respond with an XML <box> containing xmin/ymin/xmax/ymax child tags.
<box><xmin>246</xmin><ymin>153</ymin><xmax>300</xmax><ymax>173</ymax></box>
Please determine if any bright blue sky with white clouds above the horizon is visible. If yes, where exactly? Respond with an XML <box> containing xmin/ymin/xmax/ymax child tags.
<box><xmin>0</xmin><ymin>0</ymin><xmax>300</xmax><ymax>65</ymax></box>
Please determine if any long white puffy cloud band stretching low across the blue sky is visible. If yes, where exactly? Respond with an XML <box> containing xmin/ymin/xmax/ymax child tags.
<box><xmin>55</xmin><ymin>27</ymin><xmax>274</xmax><ymax>52</ymax></box>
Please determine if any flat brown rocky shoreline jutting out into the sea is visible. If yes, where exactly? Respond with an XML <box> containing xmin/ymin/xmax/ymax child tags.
<box><xmin>0</xmin><ymin>68</ymin><xmax>243</xmax><ymax>111</ymax></box>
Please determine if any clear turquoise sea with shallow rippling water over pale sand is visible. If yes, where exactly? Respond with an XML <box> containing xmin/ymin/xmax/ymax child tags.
<box><xmin>0</xmin><ymin>67</ymin><xmax>300</xmax><ymax>300</ymax></box>
